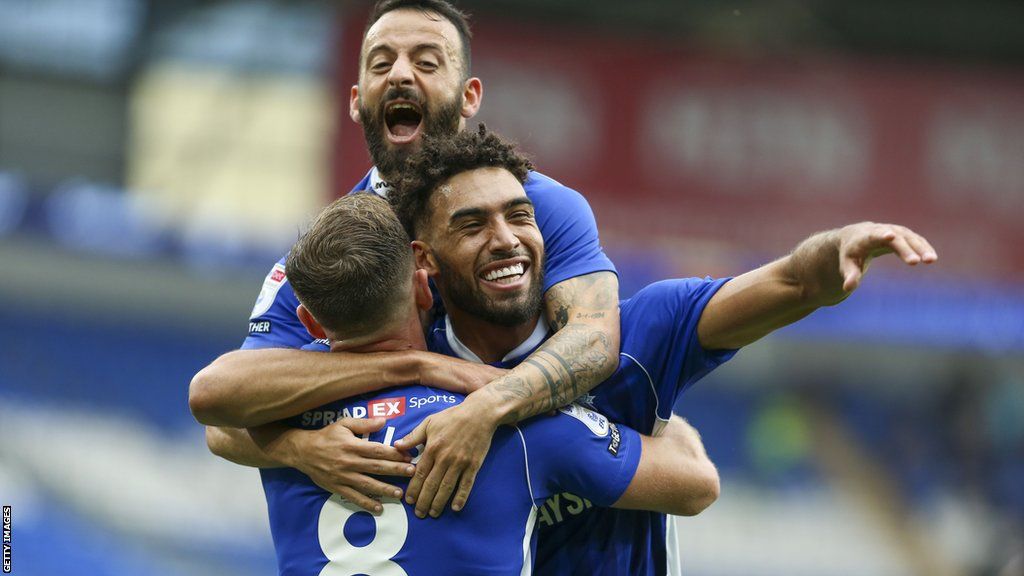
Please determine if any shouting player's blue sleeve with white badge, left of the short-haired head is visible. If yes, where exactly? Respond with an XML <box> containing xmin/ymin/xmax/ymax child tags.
<box><xmin>242</xmin><ymin>256</ymin><xmax>312</xmax><ymax>349</ymax></box>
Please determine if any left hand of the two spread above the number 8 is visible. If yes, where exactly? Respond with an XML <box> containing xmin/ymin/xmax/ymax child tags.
<box><xmin>288</xmin><ymin>418</ymin><xmax>416</xmax><ymax>513</ymax></box>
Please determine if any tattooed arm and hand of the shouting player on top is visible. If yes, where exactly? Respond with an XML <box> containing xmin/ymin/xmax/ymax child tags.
<box><xmin>395</xmin><ymin>272</ymin><xmax>618</xmax><ymax>518</ymax></box>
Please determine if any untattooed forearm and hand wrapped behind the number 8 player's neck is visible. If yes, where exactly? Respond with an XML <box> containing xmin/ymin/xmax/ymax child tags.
<box><xmin>188</xmin><ymin>348</ymin><xmax>497</xmax><ymax>427</ymax></box>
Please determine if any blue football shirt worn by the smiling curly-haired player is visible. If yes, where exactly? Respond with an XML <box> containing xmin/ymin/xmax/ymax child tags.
<box><xmin>428</xmin><ymin>278</ymin><xmax>735</xmax><ymax>576</ymax></box>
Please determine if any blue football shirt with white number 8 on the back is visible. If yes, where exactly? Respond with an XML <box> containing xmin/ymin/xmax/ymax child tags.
<box><xmin>260</xmin><ymin>385</ymin><xmax>640</xmax><ymax>576</ymax></box>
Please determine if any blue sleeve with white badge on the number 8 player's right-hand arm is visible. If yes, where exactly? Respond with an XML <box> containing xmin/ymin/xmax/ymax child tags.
<box><xmin>518</xmin><ymin>404</ymin><xmax>641</xmax><ymax>506</ymax></box>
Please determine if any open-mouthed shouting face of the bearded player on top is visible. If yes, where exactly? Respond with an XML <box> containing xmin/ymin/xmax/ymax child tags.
<box><xmin>349</xmin><ymin>8</ymin><xmax>482</xmax><ymax>177</ymax></box>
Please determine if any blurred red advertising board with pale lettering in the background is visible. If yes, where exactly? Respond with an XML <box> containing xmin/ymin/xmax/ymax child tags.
<box><xmin>337</xmin><ymin>15</ymin><xmax>1024</xmax><ymax>280</ymax></box>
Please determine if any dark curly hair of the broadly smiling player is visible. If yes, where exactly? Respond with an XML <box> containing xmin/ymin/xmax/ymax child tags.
<box><xmin>388</xmin><ymin>124</ymin><xmax>534</xmax><ymax>239</ymax></box>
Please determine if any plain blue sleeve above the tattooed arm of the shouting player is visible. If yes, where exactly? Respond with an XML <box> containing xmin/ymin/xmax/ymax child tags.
<box><xmin>523</xmin><ymin>172</ymin><xmax>615</xmax><ymax>291</ymax></box>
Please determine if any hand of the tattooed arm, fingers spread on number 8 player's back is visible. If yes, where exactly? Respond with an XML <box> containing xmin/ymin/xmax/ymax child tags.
<box><xmin>394</xmin><ymin>397</ymin><xmax>498</xmax><ymax>518</ymax></box>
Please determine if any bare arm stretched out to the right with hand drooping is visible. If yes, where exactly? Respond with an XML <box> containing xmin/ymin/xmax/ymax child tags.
<box><xmin>697</xmin><ymin>222</ymin><xmax>938</xmax><ymax>349</ymax></box>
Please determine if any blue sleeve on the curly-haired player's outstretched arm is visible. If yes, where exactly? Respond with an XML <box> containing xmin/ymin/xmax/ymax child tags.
<box><xmin>620</xmin><ymin>278</ymin><xmax>736</xmax><ymax>419</ymax></box>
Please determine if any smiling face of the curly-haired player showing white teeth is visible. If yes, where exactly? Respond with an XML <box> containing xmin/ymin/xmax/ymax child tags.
<box><xmin>414</xmin><ymin>168</ymin><xmax>544</xmax><ymax>327</ymax></box>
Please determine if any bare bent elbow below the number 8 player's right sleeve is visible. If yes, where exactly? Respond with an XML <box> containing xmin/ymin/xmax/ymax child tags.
<box><xmin>612</xmin><ymin>415</ymin><xmax>720</xmax><ymax>516</ymax></box>
